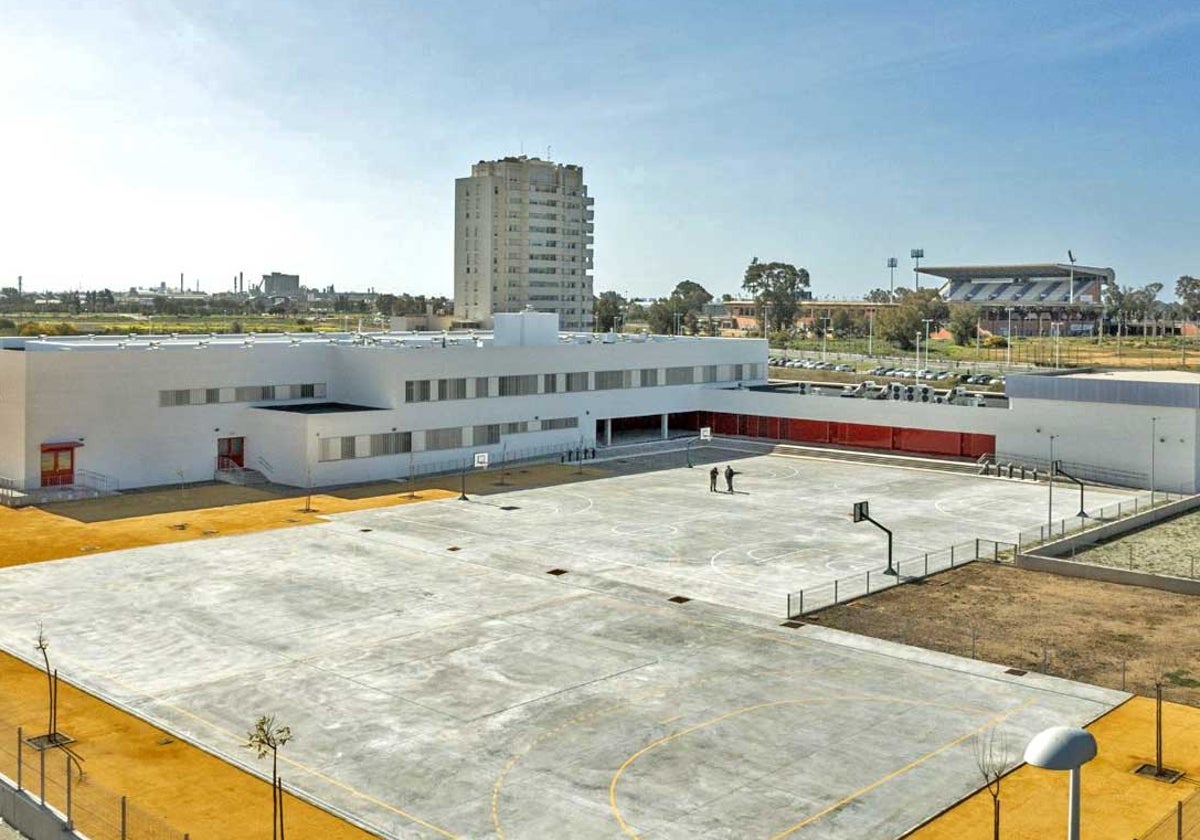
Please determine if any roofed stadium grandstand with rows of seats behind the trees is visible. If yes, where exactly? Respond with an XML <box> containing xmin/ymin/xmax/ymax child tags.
<box><xmin>918</xmin><ymin>263</ymin><xmax>1116</xmax><ymax>336</ymax></box>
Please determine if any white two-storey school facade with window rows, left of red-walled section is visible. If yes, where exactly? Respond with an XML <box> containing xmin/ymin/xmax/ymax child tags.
<box><xmin>0</xmin><ymin>316</ymin><xmax>767</xmax><ymax>488</ymax></box>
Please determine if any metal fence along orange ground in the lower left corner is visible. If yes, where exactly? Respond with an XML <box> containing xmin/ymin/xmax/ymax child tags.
<box><xmin>0</xmin><ymin>721</ymin><xmax>187</xmax><ymax>840</ymax></box>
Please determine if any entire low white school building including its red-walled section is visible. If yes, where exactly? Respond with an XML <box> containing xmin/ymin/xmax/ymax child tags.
<box><xmin>0</xmin><ymin>312</ymin><xmax>1200</xmax><ymax>498</ymax></box>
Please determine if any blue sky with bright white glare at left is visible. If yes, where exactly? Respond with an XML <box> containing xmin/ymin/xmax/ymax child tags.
<box><xmin>0</xmin><ymin>0</ymin><xmax>1200</xmax><ymax>296</ymax></box>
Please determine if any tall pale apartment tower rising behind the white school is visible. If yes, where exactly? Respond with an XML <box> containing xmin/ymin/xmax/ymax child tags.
<box><xmin>454</xmin><ymin>155</ymin><xmax>593</xmax><ymax>330</ymax></box>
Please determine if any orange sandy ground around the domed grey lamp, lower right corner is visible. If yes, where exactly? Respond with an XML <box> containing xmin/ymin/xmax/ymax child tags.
<box><xmin>907</xmin><ymin>697</ymin><xmax>1200</xmax><ymax>840</ymax></box>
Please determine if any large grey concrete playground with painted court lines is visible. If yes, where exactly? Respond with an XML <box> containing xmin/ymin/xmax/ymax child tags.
<box><xmin>0</xmin><ymin>452</ymin><xmax>1126</xmax><ymax>840</ymax></box>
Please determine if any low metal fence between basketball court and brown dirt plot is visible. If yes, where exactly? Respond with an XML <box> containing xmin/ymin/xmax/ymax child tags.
<box><xmin>787</xmin><ymin>540</ymin><xmax>1016</xmax><ymax>618</ymax></box>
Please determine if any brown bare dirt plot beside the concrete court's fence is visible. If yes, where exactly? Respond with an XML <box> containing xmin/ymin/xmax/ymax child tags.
<box><xmin>805</xmin><ymin>563</ymin><xmax>1200</xmax><ymax>706</ymax></box>
